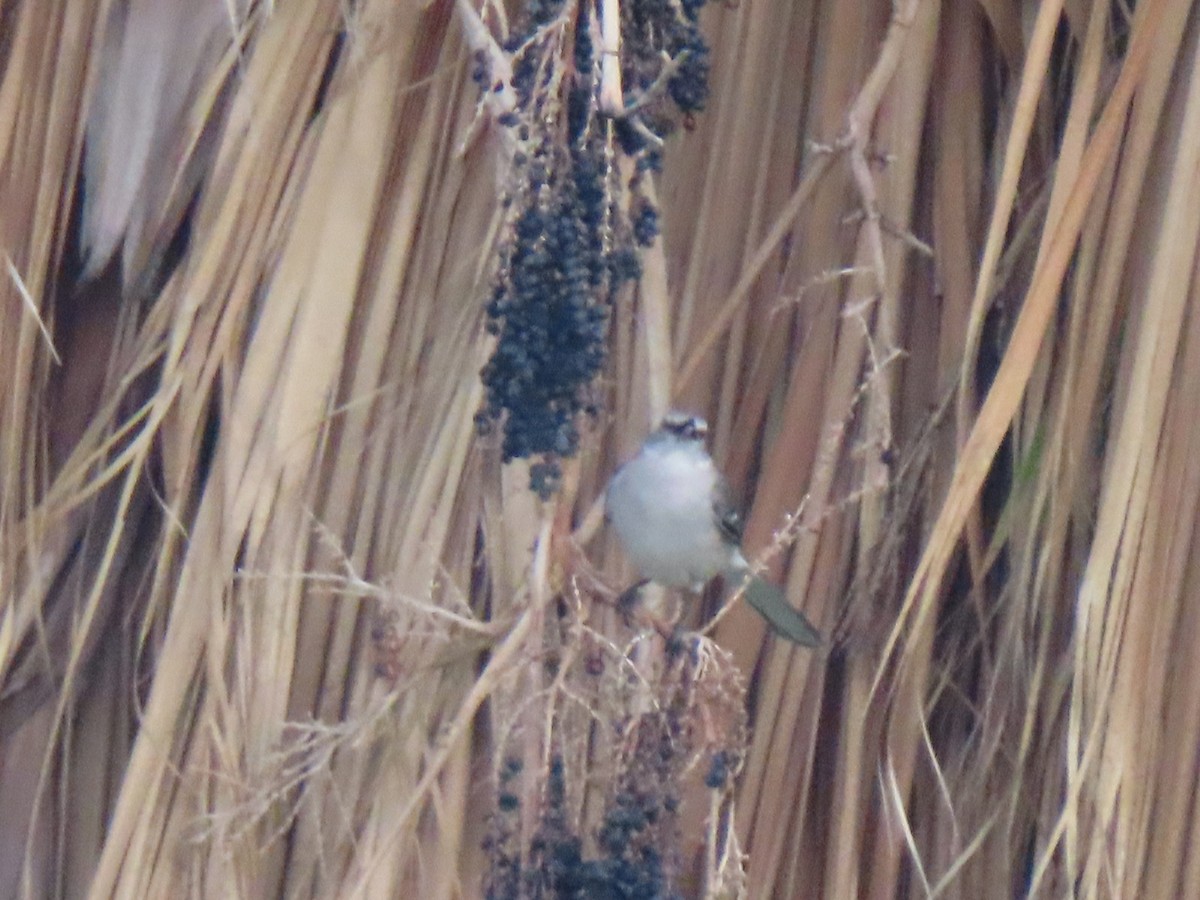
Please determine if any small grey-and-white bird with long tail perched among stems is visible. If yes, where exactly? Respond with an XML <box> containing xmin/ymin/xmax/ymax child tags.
<box><xmin>605</xmin><ymin>413</ymin><xmax>821</xmax><ymax>647</ymax></box>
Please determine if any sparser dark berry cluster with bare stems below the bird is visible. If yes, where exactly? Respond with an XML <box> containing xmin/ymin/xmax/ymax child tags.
<box><xmin>484</xmin><ymin>641</ymin><xmax>748</xmax><ymax>900</ymax></box>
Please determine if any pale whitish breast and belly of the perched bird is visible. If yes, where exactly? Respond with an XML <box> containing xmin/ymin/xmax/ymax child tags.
<box><xmin>607</xmin><ymin>440</ymin><xmax>737</xmax><ymax>587</ymax></box>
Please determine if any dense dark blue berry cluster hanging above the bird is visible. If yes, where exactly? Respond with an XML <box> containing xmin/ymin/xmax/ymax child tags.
<box><xmin>474</xmin><ymin>0</ymin><xmax>708</xmax><ymax>498</ymax></box>
